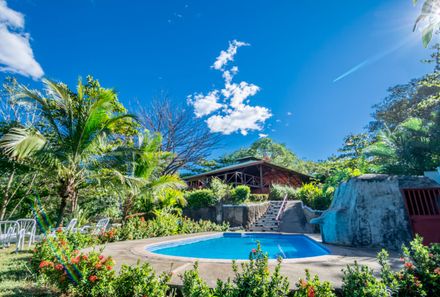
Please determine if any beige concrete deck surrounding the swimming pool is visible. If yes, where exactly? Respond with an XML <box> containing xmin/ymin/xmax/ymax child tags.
<box><xmin>87</xmin><ymin>232</ymin><xmax>401</xmax><ymax>288</ymax></box>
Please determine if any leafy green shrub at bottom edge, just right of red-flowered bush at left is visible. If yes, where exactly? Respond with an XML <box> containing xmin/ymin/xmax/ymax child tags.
<box><xmin>113</xmin><ymin>262</ymin><xmax>171</xmax><ymax>297</ymax></box>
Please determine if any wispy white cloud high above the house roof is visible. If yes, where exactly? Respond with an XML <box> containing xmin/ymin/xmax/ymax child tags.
<box><xmin>188</xmin><ymin>40</ymin><xmax>272</xmax><ymax>135</ymax></box>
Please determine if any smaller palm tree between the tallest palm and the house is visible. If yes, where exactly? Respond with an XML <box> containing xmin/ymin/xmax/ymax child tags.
<box><xmin>107</xmin><ymin>132</ymin><xmax>186</xmax><ymax>219</ymax></box>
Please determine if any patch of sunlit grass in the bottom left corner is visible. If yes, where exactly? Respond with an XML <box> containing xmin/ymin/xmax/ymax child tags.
<box><xmin>0</xmin><ymin>246</ymin><xmax>57</xmax><ymax>297</ymax></box>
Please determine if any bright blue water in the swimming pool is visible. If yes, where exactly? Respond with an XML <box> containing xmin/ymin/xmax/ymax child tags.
<box><xmin>147</xmin><ymin>233</ymin><xmax>329</xmax><ymax>260</ymax></box>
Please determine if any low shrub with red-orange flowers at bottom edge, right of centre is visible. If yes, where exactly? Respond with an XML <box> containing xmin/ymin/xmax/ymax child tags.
<box><xmin>293</xmin><ymin>269</ymin><xmax>336</xmax><ymax>297</ymax></box>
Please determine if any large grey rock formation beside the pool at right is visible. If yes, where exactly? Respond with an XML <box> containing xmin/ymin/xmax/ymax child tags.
<box><xmin>312</xmin><ymin>174</ymin><xmax>439</xmax><ymax>249</ymax></box>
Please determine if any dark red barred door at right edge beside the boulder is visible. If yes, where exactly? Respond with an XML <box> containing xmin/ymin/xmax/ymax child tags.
<box><xmin>402</xmin><ymin>188</ymin><xmax>440</xmax><ymax>244</ymax></box>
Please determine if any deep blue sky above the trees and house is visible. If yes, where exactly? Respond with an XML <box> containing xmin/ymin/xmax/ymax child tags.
<box><xmin>0</xmin><ymin>0</ymin><xmax>432</xmax><ymax>160</ymax></box>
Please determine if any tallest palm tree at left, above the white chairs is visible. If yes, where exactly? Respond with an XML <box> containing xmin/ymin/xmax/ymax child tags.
<box><xmin>0</xmin><ymin>77</ymin><xmax>134</xmax><ymax>226</ymax></box>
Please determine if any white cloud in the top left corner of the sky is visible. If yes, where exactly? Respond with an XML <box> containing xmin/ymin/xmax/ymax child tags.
<box><xmin>0</xmin><ymin>0</ymin><xmax>44</xmax><ymax>78</ymax></box>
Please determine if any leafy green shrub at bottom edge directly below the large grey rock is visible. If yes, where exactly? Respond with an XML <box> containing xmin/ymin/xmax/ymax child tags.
<box><xmin>342</xmin><ymin>262</ymin><xmax>389</xmax><ymax>297</ymax></box>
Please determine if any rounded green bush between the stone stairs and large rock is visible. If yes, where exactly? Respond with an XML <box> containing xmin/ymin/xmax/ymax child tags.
<box><xmin>296</xmin><ymin>183</ymin><xmax>332</xmax><ymax>210</ymax></box>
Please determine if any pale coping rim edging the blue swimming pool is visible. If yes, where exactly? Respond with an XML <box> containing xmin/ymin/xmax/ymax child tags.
<box><xmin>143</xmin><ymin>232</ymin><xmax>332</xmax><ymax>264</ymax></box>
